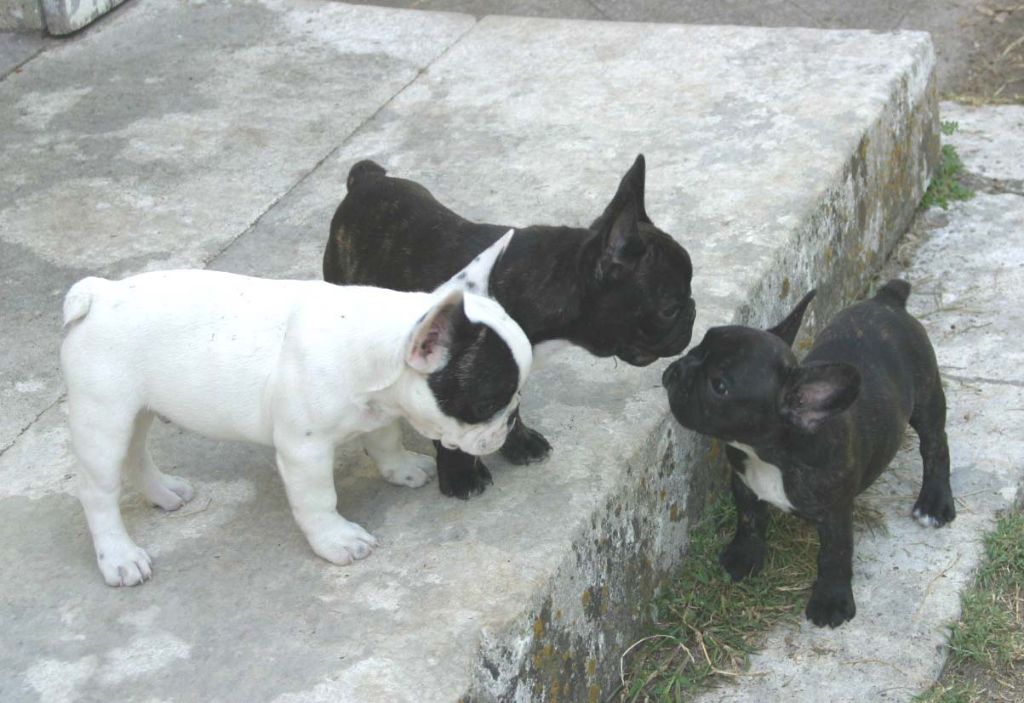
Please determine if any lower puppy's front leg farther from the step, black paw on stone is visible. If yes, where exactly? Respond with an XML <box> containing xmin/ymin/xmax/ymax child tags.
<box><xmin>807</xmin><ymin>508</ymin><xmax>857</xmax><ymax>627</ymax></box>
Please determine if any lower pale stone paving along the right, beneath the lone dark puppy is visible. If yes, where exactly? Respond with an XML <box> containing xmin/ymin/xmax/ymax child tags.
<box><xmin>699</xmin><ymin>103</ymin><xmax>1024</xmax><ymax>703</ymax></box>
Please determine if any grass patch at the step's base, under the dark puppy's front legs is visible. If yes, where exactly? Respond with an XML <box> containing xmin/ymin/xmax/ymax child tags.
<box><xmin>620</xmin><ymin>495</ymin><xmax>885</xmax><ymax>701</ymax></box>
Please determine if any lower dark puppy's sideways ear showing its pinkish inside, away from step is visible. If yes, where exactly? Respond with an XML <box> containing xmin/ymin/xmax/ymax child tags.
<box><xmin>780</xmin><ymin>361</ymin><xmax>860</xmax><ymax>432</ymax></box>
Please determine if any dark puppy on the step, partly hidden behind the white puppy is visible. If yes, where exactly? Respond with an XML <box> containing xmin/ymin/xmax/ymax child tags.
<box><xmin>324</xmin><ymin>155</ymin><xmax>694</xmax><ymax>498</ymax></box>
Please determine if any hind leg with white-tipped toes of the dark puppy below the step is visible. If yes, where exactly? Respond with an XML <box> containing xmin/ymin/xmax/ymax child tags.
<box><xmin>910</xmin><ymin>378</ymin><xmax>956</xmax><ymax>527</ymax></box>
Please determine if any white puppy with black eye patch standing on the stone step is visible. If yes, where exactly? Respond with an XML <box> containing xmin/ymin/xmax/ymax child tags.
<box><xmin>60</xmin><ymin>232</ymin><xmax>532</xmax><ymax>585</ymax></box>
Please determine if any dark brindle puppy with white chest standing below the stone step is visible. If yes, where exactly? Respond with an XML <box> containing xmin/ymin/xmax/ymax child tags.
<box><xmin>663</xmin><ymin>280</ymin><xmax>956</xmax><ymax>627</ymax></box>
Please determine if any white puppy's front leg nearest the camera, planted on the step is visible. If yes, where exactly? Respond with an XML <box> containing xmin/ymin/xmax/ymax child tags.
<box><xmin>274</xmin><ymin>437</ymin><xmax>377</xmax><ymax>565</ymax></box>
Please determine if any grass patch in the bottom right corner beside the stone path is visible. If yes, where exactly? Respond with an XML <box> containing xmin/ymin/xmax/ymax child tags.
<box><xmin>918</xmin><ymin>511</ymin><xmax>1024</xmax><ymax>703</ymax></box>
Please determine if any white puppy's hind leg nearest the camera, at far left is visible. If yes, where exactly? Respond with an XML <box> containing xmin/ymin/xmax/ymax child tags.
<box><xmin>69</xmin><ymin>398</ymin><xmax>153</xmax><ymax>586</ymax></box>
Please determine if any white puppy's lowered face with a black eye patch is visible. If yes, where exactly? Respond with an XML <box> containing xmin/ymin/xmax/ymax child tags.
<box><xmin>409</xmin><ymin>296</ymin><xmax>532</xmax><ymax>455</ymax></box>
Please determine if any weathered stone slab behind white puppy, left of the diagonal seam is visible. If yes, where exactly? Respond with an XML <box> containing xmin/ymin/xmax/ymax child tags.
<box><xmin>0</xmin><ymin>0</ymin><xmax>473</xmax><ymax>450</ymax></box>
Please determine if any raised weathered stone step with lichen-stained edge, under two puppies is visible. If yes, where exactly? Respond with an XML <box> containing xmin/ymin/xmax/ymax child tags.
<box><xmin>0</xmin><ymin>0</ymin><xmax>937</xmax><ymax>701</ymax></box>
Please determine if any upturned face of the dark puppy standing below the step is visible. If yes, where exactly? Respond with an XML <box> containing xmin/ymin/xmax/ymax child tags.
<box><xmin>662</xmin><ymin>326</ymin><xmax>797</xmax><ymax>444</ymax></box>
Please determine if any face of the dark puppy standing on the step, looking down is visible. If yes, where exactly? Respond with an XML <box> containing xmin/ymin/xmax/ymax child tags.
<box><xmin>573</xmin><ymin>223</ymin><xmax>695</xmax><ymax>366</ymax></box>
